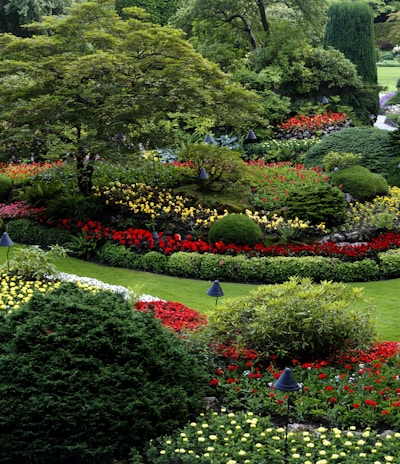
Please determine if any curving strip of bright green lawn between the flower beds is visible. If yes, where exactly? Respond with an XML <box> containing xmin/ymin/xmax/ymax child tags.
<box><xmin>0</xmin><ymin>248</ymin><xmax>400</xmax><ymax>341</ymax></box>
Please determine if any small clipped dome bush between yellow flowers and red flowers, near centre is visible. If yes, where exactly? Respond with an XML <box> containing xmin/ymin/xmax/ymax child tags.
<box><xmin>208</xmin><ymin>213</ymin><xmax>262</xmax><ymax>246</ymax></box>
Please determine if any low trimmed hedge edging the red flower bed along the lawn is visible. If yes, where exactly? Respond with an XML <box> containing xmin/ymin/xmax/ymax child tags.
<box><xmin>7</xmin><ymin>219</ymin><xmax>400</xmax><ymax>284</ymax></box>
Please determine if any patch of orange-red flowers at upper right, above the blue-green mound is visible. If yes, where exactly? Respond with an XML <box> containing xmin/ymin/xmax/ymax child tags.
<box><xmin>278</xmin><ymin>111</ymin><xmax>348</xmax><ymax>137</ymax></box>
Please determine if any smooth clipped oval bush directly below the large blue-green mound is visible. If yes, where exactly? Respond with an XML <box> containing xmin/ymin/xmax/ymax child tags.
<box><xmin>331</xmin><ymin>165</ymin><xmax>389</xmax><ymax>202</ymax></box>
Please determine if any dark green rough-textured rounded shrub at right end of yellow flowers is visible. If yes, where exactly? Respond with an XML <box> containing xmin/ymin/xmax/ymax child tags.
<box><xmin>285</xmin><ymin>182</ymin><xmax>346</xmax><ymax>228</ymax></box>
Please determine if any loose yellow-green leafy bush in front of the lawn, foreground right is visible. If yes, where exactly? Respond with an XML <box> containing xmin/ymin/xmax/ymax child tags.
<box><xmin>209</xmin><ymin>278</ymin><xmax>374</xmax><ymax>361</ymax></box>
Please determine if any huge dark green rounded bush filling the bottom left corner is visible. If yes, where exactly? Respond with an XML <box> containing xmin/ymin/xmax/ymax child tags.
<box><xmin>0</xmin><ymin>283</ymin><xmax>208</xmax><ymax>464</ymax></box>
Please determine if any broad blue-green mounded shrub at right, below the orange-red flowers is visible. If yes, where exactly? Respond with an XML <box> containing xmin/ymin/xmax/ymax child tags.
<box><xmin>304</xmin><ymin>127</ymin><xmax>395</xmax><ymax>178</ymax></box>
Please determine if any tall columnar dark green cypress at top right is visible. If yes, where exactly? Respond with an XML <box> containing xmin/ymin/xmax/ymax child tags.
<box><xmin>324</xmin><ymin>1</ymin><xmax>377</xmax><ymax>84</ymax></box>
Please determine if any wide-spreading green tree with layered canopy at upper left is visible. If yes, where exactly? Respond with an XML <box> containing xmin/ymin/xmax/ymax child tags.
<box><xmin>0</xmin><ymin>0</ymin><xmax>263</xmax><ymax>191</ymax></box>
